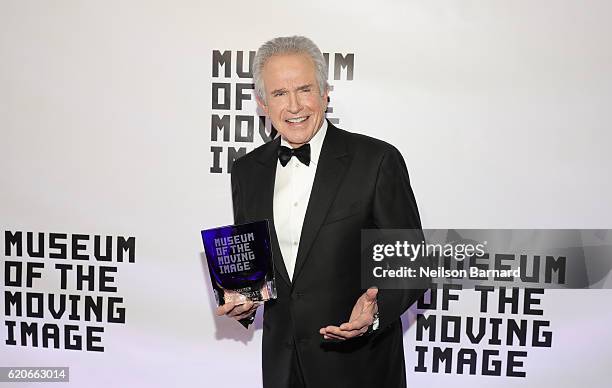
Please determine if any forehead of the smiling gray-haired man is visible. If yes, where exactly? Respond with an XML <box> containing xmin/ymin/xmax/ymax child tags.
<box><xmin>261</xmin><ymin>54</ymin><xmax>316</xmax><ymax>90</ymax></box>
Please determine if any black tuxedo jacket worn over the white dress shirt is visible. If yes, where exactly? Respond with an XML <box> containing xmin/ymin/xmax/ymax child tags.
<box><xmin>232</xmin><ymin>123</ymin><xmax>423</xmax><ymax>388</ymax></box>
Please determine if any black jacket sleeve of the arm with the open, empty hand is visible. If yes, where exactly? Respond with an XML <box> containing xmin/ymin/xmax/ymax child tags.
<box><xmin>373</xmin><ymin>147</ymin><xmax>426</xmax><ymax>330</ymax></box>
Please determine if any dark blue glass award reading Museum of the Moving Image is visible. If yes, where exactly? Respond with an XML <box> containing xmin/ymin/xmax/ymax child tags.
<box><xmin>202</xmin><ymin>220</ymin><xmax>276</xmax><ymax>327</ymax></box>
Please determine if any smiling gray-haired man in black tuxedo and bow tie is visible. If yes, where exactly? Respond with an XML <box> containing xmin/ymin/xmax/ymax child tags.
<box><xmin>217</xmin><ymin>36</ymin><xmax>423</xmax><ymax>388</ymax></box>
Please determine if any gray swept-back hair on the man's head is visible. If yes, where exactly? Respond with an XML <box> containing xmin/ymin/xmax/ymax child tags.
<box><xmin>253</xmin><ymin>36</ymin><xmax>329</xmax><ymax>102</ymax></box>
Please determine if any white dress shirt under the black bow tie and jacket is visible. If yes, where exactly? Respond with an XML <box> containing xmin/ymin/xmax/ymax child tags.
<box><xmin>274</xmin><ymin>119</ymin><xmax>327</xmax><ymax>280</ymax></box>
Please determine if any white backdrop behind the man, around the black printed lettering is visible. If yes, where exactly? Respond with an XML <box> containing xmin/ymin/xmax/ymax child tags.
<box><xmin>0</xmin><ymin>0</ymin><xmax>612</xmax><ymax>388</ymax></box>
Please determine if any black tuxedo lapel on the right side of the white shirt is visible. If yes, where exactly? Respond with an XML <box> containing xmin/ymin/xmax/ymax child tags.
<box><xmin>293</xmin><ymin>123</ymin><xmax>350</xmax><ymax>284</ymax></box>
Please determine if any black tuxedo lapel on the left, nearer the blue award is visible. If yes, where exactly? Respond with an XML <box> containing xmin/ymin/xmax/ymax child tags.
<box><xmin>254</xmin><ymin>137</ymin><xmax>291</xmax><ymax>285</ymax></box>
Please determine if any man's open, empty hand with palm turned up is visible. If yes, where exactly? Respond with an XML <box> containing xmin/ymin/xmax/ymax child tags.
<box><xmin>319</xmin><ymin>288</ymin><xmax>378</xmax><ymax>341</ymax></box>
